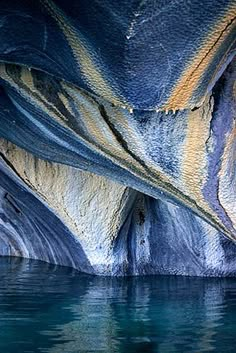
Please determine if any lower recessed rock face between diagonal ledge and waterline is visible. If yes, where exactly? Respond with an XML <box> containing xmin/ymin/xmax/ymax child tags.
<box><xmin>0</xmin><ymin>140</ymin><xmax>236</xmax><ymax>276</ymax></box>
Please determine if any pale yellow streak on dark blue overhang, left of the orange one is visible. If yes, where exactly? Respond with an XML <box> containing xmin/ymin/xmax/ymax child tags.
<box><xmin>41</xmin><ymin>0</ymin><xmax>126</xmax><ymax>106</ymax></box>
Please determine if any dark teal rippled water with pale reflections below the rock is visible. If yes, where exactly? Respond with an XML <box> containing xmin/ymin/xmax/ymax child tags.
<box><xmin>0</xmin><ymin>258</ymin><xmax>236</xmax><ymax>353</ymax></box>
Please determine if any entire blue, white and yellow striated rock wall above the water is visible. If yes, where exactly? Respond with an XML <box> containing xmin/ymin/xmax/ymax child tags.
<box><xmin>0</xmin><ymin>0</ymin><xmax>236</xmax><ymax>276</ymax></box>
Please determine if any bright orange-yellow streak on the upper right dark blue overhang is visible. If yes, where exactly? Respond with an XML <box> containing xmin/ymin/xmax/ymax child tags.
<box><xmin>161</xmin><ymin>6</ymin><xmax>236</xmax><ymax>111</ymax></box>
